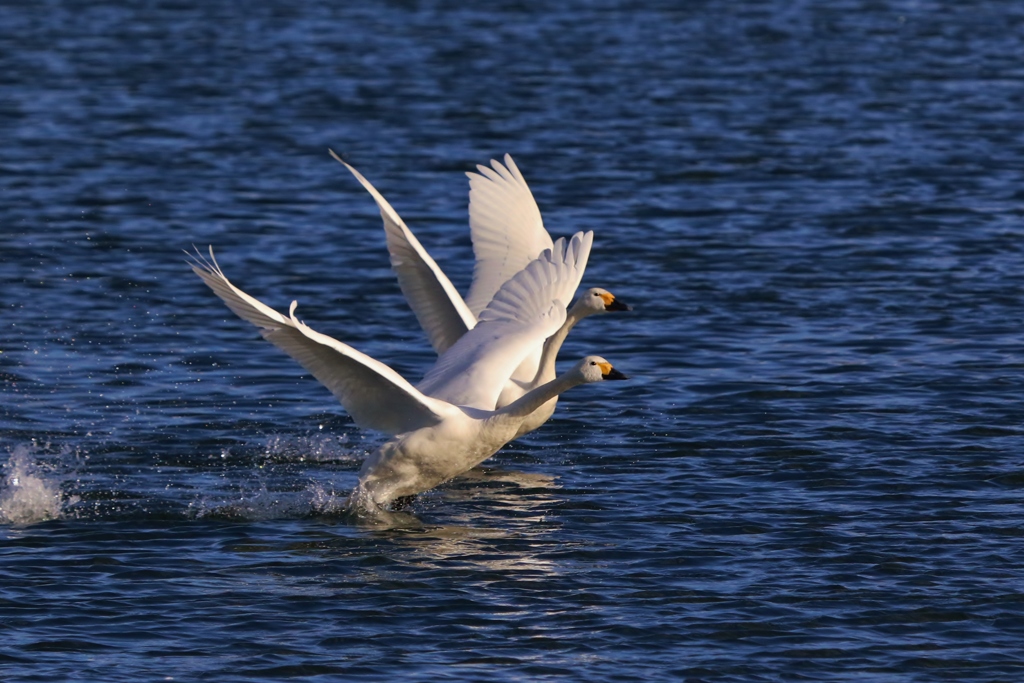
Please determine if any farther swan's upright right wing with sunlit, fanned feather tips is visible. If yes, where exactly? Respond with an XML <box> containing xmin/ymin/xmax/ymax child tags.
<box><xmin>466</xmin><ymin>155</ymin><xmax>567</xmax><ymax>315</ymax></box>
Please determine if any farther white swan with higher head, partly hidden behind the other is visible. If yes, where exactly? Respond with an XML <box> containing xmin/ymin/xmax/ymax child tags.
<box><xmin>329</xmin><ymin>150</ymin><xmax>632</xmax><ymax>436</ymax></box>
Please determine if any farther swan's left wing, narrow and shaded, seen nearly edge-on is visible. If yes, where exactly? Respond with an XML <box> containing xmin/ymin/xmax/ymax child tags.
<box><xmin>328</xmin><ymin>150</ymin><xmax>481</xmax><ymax>354</ymax></box>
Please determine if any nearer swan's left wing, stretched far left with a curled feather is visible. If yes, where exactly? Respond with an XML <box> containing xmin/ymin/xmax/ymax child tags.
<box><xmin>190</xmin><ymin>248</ymin><xmax>451</xmax><ymax>435</ymax></box>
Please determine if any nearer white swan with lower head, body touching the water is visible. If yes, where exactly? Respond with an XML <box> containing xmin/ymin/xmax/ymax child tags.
<box><xmin>190</xmin><ymin>233</ymin><xmax>626</xmax><ymax>509</ymax></box>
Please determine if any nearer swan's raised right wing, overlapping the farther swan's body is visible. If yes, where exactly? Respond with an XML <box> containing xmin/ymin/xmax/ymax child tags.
<box><xmin>418</xmin><ymin>232</ymin><xmax>594</xmax><ymax>411</ymax></box>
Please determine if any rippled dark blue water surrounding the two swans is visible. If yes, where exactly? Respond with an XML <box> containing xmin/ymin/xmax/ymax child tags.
<box><xmin>0</xmin><ymin>0</ymin><xmax>1024</xmax><ymax>682</ymax></box>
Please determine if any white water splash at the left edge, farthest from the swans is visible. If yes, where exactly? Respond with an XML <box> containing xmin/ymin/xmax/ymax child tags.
<box><xmin>0</xmin><ymin>445</ymin><xmax>74</xmax><ymax>524</ymax></box>
